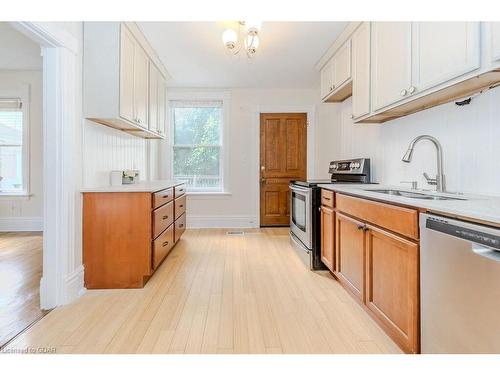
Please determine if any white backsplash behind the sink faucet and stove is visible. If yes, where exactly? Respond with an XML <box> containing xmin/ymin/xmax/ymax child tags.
<box><xmin>335</xmin><ymin>88</ymin><xmax>500</xmax><ymax>196</ymax></box>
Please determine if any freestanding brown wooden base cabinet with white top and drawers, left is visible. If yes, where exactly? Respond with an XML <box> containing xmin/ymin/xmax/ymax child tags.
<box><xmin>83</xmin><ymin>181</ymin><xmax>186</xmax><ymax>289</ymax></box>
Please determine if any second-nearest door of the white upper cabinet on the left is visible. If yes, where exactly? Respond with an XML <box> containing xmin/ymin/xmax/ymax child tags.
<box><xmin>134</xmin><ymin>44</ymin><xmax>149</xmax><ymax>128</ymax></box>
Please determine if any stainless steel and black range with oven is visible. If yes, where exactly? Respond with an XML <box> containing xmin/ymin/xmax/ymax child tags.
<box><xmin>290</xmin><ymin>158</ymin><xmax>372</xmax><ymax>270</ymax></box>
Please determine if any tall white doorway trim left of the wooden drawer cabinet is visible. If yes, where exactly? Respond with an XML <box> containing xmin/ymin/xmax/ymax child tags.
<box><xmin>12</xmin><ymin>22</ymin><xmax>84</xmax><ymax>309</ymax></box>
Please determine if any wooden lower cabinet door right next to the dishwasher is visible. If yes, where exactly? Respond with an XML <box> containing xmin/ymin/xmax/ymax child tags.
<box><xmin>365</xmin><ymin>227</ymin><xmax>419</xmax><ymax>353</ymax></box>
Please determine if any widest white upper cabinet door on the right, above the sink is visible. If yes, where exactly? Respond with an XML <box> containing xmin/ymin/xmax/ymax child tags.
<box><xmin>410</xmin><ymin>22</ymin><xmax>481</xmax><ymax>94</ymax></box>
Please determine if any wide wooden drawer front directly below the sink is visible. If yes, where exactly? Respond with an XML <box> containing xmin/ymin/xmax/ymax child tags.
<box><xmin>335</xmin><ymin>194</ymin><xmax>418</xmax><ymax>239</ymax></box>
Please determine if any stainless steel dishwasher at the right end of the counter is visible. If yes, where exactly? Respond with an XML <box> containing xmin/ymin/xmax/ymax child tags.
<box><xmin>420</xmin><ymin>214</ymin><xmax>500</xmax><ymax>353</ymax></box>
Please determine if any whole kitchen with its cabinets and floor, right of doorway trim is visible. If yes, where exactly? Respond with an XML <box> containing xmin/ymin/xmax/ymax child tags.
<box><xmin>2</xmin><ymin>0</ymin><xmax>500</xmax><ymax>374</ymax></box>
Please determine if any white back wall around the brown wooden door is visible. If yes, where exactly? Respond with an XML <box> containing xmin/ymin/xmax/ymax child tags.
<box><xmin>163</xmin><ymin>89</ymin><xmax>337</xmax><ymax>227</ymax></box>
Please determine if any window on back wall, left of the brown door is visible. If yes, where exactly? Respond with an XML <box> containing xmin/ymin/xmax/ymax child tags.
<box><xmin>170</xmin><ymin>100</ymin><xmax>224</xmax><ymax>192</ymax></box>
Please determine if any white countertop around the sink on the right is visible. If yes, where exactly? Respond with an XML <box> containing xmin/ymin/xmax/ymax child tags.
<box><xmin>319</xmin><ymin>184</ymin><xmax>500</xmax><ymax>225</ymax></box>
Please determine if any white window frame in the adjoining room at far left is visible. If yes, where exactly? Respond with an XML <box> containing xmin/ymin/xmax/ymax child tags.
<box><xmin>0</xmin><ymin>85</ymin><xmax>31</xmax><ymax>198</ymax></box>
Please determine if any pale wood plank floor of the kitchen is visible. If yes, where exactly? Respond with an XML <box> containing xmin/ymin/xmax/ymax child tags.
<box><xmin>4</xmin><ymin>228</ymin><xmax>400</xmax><ymax>353</ymax></box>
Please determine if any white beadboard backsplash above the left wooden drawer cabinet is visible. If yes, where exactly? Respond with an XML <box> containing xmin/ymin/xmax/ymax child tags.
<box><xmin>83</xmin><ymin>121</ymin><xmax>148</xmax><ymax>187</ymax></box>
